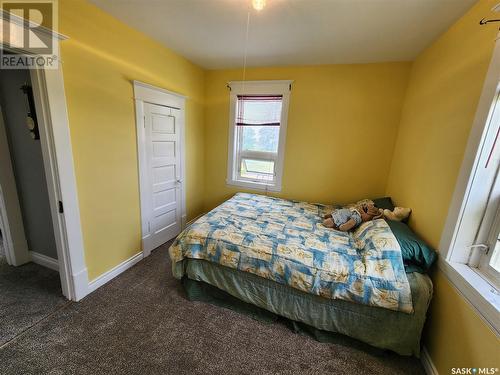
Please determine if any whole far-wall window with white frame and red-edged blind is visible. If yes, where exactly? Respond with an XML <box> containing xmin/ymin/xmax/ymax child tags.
<box><xmin>227</xmin><ymin>81</ymin><xmax>291</xmax><ymax>191</ymax></box>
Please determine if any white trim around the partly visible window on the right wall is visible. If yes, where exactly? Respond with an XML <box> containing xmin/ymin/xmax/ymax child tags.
<box><xmin>438</xmin><ymin>29</ymin><xmax>500</xmax><ymax>336</ymax></box>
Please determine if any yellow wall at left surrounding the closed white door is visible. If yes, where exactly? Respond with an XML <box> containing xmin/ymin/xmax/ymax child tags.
<box><xmin>59</xmin><ymin>0</ymin><xmax>205</xmax><ymax>280</ymax></box>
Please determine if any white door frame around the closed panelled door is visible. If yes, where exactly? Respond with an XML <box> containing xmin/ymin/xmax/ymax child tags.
<box><xmin>132</xmin><ymin>80</ymin><xmax>187</xmax><ymax>257</ymax></box>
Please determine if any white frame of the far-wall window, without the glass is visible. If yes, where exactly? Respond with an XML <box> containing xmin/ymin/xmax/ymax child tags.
<box><xmin>226</xmin><ymin>80</ymin><xmax>293</xmax><ymax>192</ymax></box>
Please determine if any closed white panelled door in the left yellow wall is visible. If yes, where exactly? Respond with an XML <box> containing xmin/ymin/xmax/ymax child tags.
<box><xmin>143</xmin><ymin>103</ymin><xmax>182</xmax><ymax>256</ymax></box>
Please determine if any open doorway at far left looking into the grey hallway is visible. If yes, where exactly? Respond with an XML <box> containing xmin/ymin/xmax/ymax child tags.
<box><xmin>0</xmin><ymin>70</ymin><xmax>67</xmax><ymax>346</ymax></box>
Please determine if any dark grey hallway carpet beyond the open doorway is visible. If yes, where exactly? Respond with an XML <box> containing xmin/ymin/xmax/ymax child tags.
<box><xmin>0</xmin><ymin>254</ymin><xmax>67</xmax><ymax>348</ymax></box>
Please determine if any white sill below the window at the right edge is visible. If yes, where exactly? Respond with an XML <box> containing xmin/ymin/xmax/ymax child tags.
<box><xmin>438</xmin><ymin>258</ymin><xmax>500</xmax><ymax>335</ymax></box>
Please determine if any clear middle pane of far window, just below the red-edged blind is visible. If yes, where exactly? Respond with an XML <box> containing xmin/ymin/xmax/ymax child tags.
<box><xmin>241</xmin><ymin>126</ymin><xmax>280</xmax><ymax>153</ymax></box>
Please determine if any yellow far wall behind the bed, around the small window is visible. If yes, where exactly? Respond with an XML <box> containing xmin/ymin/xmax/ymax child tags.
<box><xmin>205</xmin><ymin>63</ymin><xmax>411</xmax><ymax>209</ymax></box>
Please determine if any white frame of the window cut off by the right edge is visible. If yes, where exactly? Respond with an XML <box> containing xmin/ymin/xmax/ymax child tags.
<box><xmin>438</xmin><ymin>33</ymin><xmax>500</xmax><ymax>335</ymax></box>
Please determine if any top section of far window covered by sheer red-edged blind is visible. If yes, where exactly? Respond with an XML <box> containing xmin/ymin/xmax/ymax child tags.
<box><xmin>236</xmin><ymin>96</ymin><xmax>282</xmax><ymax>125</ymax></box>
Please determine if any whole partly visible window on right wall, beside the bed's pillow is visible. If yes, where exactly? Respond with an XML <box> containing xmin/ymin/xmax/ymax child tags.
<box><xmin>439</xmin><ymin>75</ymin><xmax>500</xmax><ymax>332</ymax></box>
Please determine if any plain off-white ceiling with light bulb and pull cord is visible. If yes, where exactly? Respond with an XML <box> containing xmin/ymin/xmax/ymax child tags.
<box><xmin>91</xmin><ymin>0</ymin><xmax>479</xmax><ymax>69</ymax></box>
